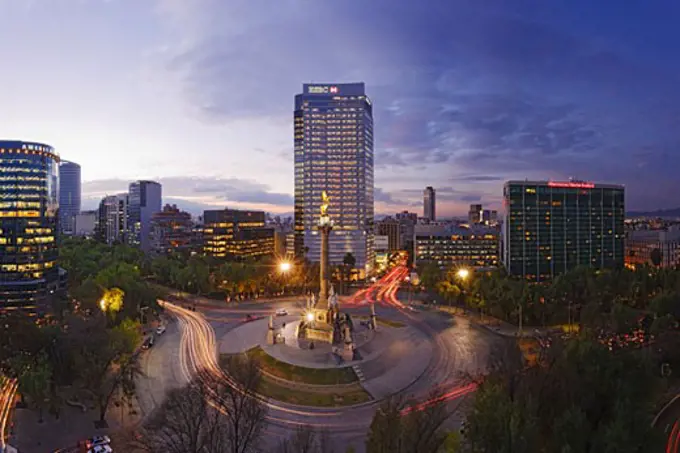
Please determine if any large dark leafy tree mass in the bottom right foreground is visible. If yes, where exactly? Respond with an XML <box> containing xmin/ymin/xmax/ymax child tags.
<box><xmin>465</xmin><ymin>337</ymin><xmax>658</xmax><ymax>453</ymax></box>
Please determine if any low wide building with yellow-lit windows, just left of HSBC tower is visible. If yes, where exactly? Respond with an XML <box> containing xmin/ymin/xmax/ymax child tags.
<box><xmin>203</xmin><ymin>209</ymin><xmax>274</xmax><ymax>258</ymax></box>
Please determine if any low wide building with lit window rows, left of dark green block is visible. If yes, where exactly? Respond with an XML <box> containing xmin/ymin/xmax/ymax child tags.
<box><xmin>414</xmin><ymin>225</ymin><xmax>500</xmax><ymax>269</ymax></box>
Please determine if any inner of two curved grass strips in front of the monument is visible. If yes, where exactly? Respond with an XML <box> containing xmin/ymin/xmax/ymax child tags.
<box><xmin>240</xmin><ymin>346</ymin><xmax>359</xmax><ymax>385</ymax></box>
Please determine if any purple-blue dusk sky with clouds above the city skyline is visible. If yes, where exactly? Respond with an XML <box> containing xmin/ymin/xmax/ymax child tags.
<box><xmin>0</xmin><ymin>0</ymin><xmax>680</xmax><ymax>217</ymax></box>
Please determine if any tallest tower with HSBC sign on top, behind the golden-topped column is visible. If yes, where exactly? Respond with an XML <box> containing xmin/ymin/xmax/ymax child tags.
<box><xmin>294</xmin><ymin>83</ymin><xmax>374</xmax><ymax>278</ymax></box>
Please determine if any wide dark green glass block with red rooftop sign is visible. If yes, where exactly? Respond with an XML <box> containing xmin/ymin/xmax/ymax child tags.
<box><xmin>503</xmin><ymin>181</ymin><xmax>625</xmax><ymax>281</ymax></box>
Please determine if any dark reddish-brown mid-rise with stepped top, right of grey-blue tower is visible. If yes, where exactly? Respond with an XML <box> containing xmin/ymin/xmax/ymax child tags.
<box><xmin>149</xmin><ymin>204</ymin><xmax>194</xmax><ymax>255</ymax></box>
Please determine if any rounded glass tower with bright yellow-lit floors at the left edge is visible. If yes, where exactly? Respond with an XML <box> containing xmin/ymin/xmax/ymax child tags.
<box><xmin>0</xmin><ymin>140</ymin><xmax>59</xmax><ymax>313</ymax></box>
